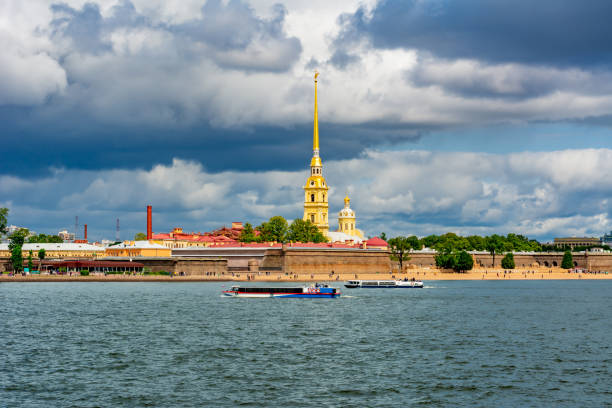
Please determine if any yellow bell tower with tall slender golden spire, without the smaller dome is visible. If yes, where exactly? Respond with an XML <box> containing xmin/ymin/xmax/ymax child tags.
<box><xmin>304</xmin><ymin>72</ymin><xmax>329</xmax><ymax>235</ymax></box>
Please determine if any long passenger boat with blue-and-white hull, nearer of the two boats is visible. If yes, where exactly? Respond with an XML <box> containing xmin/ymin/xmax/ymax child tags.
<box><xmin>223</xmin><ymin>283</ymin><xmax>340</xmax><ymax>298</ymax></box>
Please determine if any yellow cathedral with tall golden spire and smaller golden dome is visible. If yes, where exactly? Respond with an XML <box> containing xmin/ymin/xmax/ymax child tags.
<box><xmin>304</xmin><ymin>72</ymin><xmax>363</xmax><ymax>242</ymax></box>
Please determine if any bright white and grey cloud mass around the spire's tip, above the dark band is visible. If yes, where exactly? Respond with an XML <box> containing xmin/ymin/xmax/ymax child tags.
<box><xmin>0</xmin><ymin>0</ymin><xmax>612</xmax><ymax>135</ymax></box>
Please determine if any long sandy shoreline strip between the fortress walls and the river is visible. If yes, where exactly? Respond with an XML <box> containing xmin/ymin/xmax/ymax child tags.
<box><xmin>0</xmin><ymin>268</ymin><xmax>612</xmax><ymax>282</ymax></box>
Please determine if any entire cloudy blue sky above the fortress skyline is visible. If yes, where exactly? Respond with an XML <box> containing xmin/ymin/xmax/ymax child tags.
<box><xmin>0</xmin><ymin>0</ymin><xmax>612</xmax><ymax>241</ymax></box>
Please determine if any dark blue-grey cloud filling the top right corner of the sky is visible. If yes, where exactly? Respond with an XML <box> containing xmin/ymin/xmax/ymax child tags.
<box><xmin>332</xmin><ymin>0</ymin><xmax>612</xmax><ymax>66</ymax></box>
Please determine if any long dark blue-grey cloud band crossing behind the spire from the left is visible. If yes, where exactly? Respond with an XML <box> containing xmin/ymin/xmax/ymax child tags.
<box><xmin>0</xmin><ymin>103</ymin><xmax>420</xmax><ymax>178</ymax></box>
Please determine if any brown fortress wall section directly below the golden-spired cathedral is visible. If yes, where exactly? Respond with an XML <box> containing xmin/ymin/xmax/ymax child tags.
<box><xmin>283</xmin><ymin>249</ymin><xmax>391</xmax><ymax>275</ymax></box>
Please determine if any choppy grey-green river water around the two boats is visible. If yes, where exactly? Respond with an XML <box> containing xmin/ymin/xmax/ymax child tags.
<box><xmin>0</xmin><ymin>281</ymin><xmax>612</xmax><ymax>407</ymax></box>
